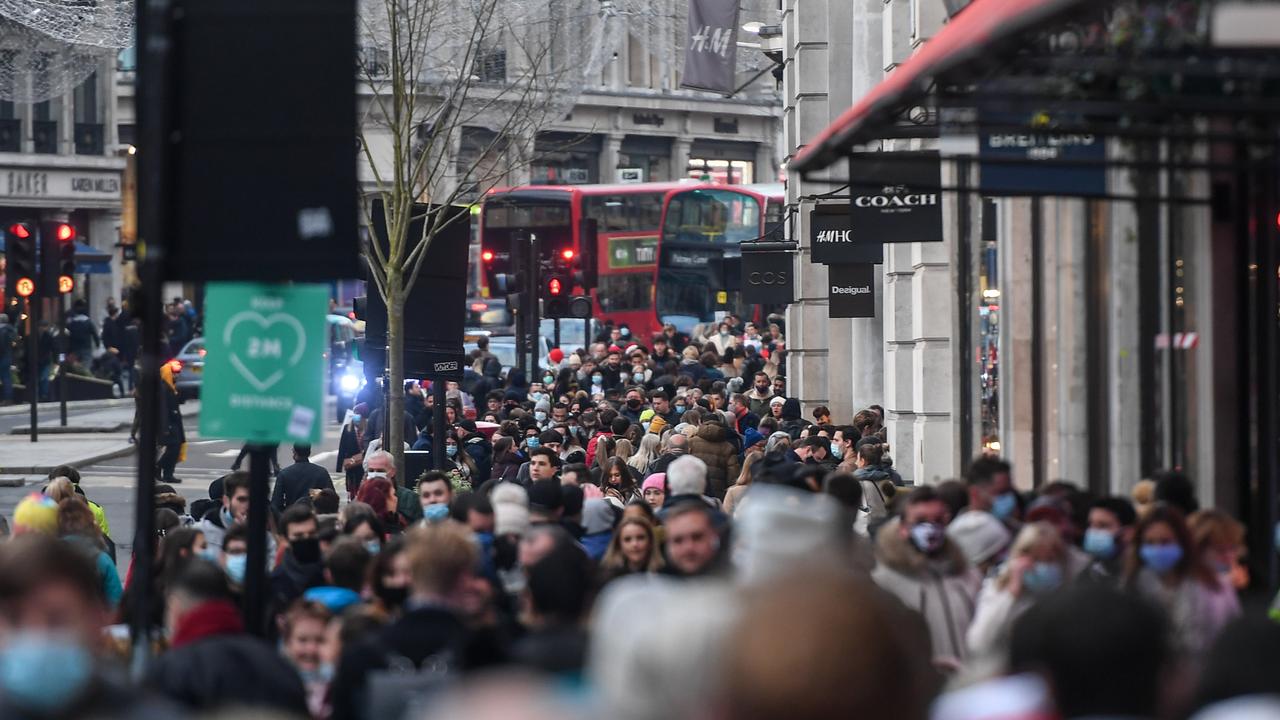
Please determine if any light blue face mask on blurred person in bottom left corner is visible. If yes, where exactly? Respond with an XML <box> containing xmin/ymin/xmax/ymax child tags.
<box><xmin>0</xmin><ymin>630</ymin><xmax>93</xmax><ymax>714</ymax></box>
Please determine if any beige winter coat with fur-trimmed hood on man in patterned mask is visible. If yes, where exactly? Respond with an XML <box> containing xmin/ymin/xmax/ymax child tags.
<box><xmin>872</xmin><ymin>519</ymin><xmax>982</xmax><ymax>661</ymax></box>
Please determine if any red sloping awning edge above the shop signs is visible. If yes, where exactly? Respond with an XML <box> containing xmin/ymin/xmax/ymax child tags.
<box><xmin>788</xmin><ymin>0</ymin><xmax>1094</xmax><ymax>173</ymax></box>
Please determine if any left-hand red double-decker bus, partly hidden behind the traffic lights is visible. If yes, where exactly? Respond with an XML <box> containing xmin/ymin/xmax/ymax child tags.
<box><xmin>480</xmin><ymin>181</ymin><xmax>696</xmax><ymax>340</ymax></box>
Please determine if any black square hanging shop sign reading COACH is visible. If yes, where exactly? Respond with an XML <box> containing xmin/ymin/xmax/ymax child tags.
<box><xmin>849</xmin><ymin>150</ymin><xmax>942</xmax><ymax>242</ymax></box>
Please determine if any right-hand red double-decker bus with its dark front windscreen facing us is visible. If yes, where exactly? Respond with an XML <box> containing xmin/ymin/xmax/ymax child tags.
<box><xmin>654</xmin><ymin>183</ymin><xmax>786</xmax><ymax>333</ymax></box>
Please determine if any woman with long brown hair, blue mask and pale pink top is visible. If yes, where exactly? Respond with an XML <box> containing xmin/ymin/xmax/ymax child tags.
<box><xmin>1124</xmin><ymin>505</ymin><xmax>1240</xmax><ymax>656</ymax></box>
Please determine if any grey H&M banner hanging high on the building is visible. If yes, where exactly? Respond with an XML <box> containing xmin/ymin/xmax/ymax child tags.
<box><xmin>680</xmin><ymin>0</ymin><xmax>739</xmax><ymax>95</ymax></box>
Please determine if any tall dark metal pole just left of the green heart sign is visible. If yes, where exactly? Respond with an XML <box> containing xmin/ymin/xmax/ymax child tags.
<box><xmin>129</xmin><ymin>0</ymin><xmax>173</xmax><ymax>680</ymax></box>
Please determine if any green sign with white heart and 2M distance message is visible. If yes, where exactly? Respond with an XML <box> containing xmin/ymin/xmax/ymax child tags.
<box><xmin>200</xmin><ymin>282</ymin><xmax>329</xmax><ymax>443</ymax></box>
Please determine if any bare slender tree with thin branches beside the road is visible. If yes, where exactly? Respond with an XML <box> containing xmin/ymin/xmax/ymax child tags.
<box><xmin>358</xmin><ymin>0</ymin><xmax>613</xmax><ymax>466</ymax></box>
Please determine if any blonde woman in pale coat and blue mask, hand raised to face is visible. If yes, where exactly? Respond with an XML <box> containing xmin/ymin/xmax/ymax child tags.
<box><xmin>966</xmin><ymin>523</ymin><xmax>1066</xmax><ymax>659</ymax></box>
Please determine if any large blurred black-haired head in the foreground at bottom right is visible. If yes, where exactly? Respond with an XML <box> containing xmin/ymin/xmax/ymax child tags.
<box><xmin>1009</xmin><ymin>583</ymin><xmax>1171</xmax><ymax>717</ymax></box>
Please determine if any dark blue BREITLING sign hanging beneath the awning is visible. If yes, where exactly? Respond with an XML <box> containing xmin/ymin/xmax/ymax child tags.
<box><xmin>978</xmin><ymin>113</ymin><xmax>1107</xmax><ymax>197</ymax></box>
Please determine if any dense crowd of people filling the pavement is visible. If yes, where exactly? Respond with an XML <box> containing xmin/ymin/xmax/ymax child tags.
<box><xmin>0</xmin><ymin>323</ymin><xmax>1280</xmax><ymax>720</ymax></box>
